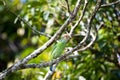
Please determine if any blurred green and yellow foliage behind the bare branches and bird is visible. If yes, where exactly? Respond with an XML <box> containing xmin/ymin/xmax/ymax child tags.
<box><xmin>0</xmin><ymin>0</ymin><xmax>120</xmax><ymax>80</ymax></box>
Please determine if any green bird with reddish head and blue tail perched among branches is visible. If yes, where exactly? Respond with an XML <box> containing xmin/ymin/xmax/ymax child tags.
<box><xmin>50</xmin><ymin>34</ymin><xmax>70</xmax><ymax>71</ymax></box>
